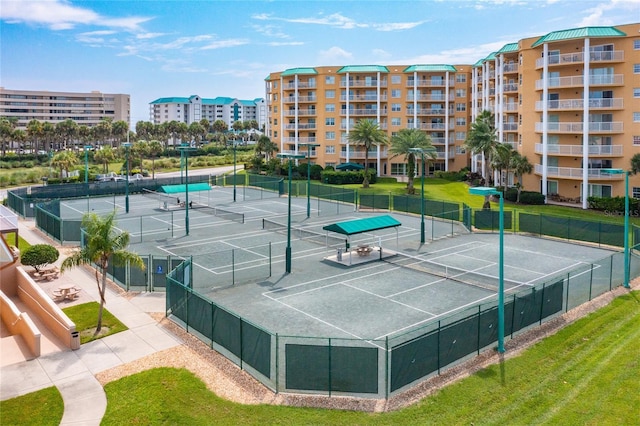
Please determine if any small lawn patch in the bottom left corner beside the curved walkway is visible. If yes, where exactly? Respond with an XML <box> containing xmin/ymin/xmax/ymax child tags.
<box><xmin>0</xmin><ymin>386</ymin><xmax>64</xmax><ymax>426</ymax></box>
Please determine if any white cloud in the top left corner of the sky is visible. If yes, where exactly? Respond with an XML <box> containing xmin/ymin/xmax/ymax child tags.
<box><xmin>0</xmin><ymin>0</ymin><xmax>151</xmax><ymax>31</ymax></box>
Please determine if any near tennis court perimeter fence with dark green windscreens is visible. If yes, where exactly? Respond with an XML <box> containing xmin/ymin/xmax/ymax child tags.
<box><xmin>167</xmin><ymin>253</ymin><xmax>640</xmax><ymax>398</ymax></box>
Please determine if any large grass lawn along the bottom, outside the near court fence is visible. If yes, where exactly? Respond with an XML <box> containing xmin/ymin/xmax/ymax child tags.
<box><xmin>103</xmin><ymin>292</ymin><xmax>640</xmax><ymax>425</ymax></box>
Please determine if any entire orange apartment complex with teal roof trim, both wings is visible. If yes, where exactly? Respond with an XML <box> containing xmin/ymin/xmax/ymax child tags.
<box><xmin>265</xmin><ymin>24</ymin><xmax>640</xmax><ymax>208</ymax></box>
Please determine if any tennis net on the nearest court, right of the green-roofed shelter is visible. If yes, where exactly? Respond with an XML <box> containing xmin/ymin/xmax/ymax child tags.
<box><xmin>382</xmin><ymin>253</ymin><xmax>533</xmax><ymax>292</ymax></box>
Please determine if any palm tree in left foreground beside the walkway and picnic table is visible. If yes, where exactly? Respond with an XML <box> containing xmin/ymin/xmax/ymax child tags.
<box><xmin>60</xmin><ymin>211</ymin><xmax>144</xmax><ymax>335</ymax></box>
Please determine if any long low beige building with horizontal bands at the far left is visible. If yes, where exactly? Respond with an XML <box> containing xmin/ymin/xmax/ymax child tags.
<box><xmin>0</xmin><ymin>87</ymin><xmax>131</xmax><ymax>129</ymax></box>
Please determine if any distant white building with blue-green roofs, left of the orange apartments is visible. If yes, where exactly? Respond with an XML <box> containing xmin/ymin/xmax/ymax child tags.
<box><xmin>149</xmin><ymin>95</ymin><xmax>267</xmax><ymax>129</ymax></box>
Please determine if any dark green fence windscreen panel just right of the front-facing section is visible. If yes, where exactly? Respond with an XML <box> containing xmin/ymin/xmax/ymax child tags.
<box><xmin>390</xmin><ymin>331</ymin><xmax>439</xmax><ymax>392</ymax></box>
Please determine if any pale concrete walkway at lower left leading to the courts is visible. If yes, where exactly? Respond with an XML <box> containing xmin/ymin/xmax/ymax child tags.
<box><xmin>0</xmin><ymin>220</ymin><xmax>182</xmax><ymax>425</ymax></box>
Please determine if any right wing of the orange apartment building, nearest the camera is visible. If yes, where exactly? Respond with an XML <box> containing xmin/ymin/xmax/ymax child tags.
<box><xmin>471</xmin><ymin>24</ymin><xmax>640</xmax><ymax>208</ymax></box>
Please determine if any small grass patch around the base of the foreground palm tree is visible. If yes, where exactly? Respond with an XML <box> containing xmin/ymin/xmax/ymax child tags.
<box><xmin>63</xmin><ymin>302</ymin><xmax>127</xmax><ymax>344</ymax></box>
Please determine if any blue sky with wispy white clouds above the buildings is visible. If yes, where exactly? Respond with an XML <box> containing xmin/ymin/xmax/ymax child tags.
<box><xmin>0</xmin><ymin>0</ymin><xmax>640</xmax><ymax>128</ymax></box>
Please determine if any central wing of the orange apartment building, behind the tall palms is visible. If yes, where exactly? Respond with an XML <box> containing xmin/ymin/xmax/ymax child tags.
<box><xmin>266</xmin><ymin>65</ymin><xmax>471</xmax><ymax>177</ymax></box>
